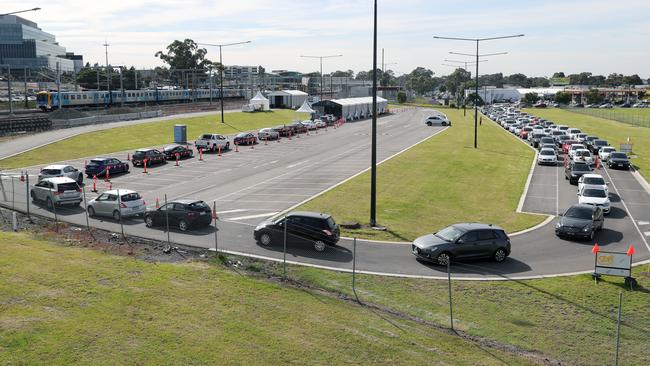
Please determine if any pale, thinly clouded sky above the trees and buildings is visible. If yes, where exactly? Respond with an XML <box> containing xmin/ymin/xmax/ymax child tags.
<box><xmin>5</xmin><ymin>0</ymin><xmax>650</xmax><ymax>79</ymax></box>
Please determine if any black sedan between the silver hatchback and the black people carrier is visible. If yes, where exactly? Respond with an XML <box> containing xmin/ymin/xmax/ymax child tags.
<box><xmin>144</xmin><ymin>200</ymin><xmax>212</xmax><ymax>231</ymax></box>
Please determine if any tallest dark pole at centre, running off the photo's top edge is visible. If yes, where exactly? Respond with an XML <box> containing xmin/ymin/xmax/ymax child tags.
<box><xmin>370</xmin><ymin>0</ymin><xmax>377</xmax><ymax>227</ymax></box>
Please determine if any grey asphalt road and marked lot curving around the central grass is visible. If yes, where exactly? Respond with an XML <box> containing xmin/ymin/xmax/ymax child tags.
<box><xmin>0</xmin><ymin>109</ymin><xmax>650</xmax><ymax>279</ymax></box>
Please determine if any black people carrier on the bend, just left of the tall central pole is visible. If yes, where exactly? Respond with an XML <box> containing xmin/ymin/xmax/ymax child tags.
<box><xmin>253</xmin><ymin>211</ymin><xmax>340</xmax><ymax>252</ymax></box>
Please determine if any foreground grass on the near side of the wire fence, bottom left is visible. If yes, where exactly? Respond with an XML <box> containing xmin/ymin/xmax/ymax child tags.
<box><xmin>0</xmin><ymin>233</ymin><xmax>531</xmax><ymax>365</ymax></box>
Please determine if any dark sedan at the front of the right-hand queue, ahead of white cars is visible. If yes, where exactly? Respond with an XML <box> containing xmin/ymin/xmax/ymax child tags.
<box><xmin>555</xmin><ymin>204</ymin><xmax>605</xmax><ymax>240</ymax></box>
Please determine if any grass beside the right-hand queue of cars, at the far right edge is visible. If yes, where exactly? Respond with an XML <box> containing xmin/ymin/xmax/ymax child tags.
<box><xmin>525</xmin><ymin>109</ymin><xmax>650</xmax><ymax>180</ymax></box>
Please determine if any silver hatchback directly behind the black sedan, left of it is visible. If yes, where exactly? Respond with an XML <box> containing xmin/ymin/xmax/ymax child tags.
<box><xmin>88</xmin><ymin>189</ymin><xmax>147</xmax><ymax>221</ymax></box>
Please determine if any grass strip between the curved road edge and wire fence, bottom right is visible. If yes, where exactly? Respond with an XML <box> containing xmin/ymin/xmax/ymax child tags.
<box><xmin>280</xmin><ymin>264</ymin><xmax>650</xmax><ymax>365</ymax></box>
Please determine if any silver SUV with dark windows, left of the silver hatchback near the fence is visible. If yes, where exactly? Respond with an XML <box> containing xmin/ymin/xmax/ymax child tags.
<box><xmin>29</xmin><ymin>177</ymin><xmax>82</xmax><ymax>210</ymax></box>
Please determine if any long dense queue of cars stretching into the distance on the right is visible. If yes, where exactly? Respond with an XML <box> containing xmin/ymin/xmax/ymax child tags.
<box><xmin>483</xmin><ymin>106</ymin><xmax>630</xmax><ymax>243</ymax></box>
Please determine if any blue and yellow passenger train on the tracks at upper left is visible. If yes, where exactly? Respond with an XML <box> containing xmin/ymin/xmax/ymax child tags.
<box><xmin>36</xmin><ymin>89</ymin><xmax>245</xmax><ymax>111</ymax></box>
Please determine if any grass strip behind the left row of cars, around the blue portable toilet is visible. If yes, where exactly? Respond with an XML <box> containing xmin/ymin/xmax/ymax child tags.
<box><xmin>0</xmin><ymin>110</ymin><xmax>304</xmax><ymax>169</ymax></box>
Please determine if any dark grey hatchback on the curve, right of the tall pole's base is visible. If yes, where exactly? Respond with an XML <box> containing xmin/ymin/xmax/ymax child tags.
<box><xmin>411</xmin><ymin>223</ymin><xmax>510</xmax><ymax>266</ymax></box>
